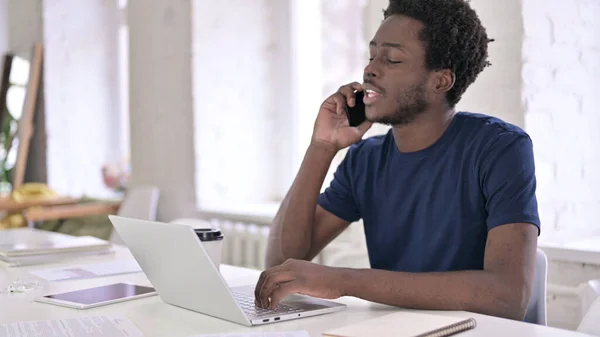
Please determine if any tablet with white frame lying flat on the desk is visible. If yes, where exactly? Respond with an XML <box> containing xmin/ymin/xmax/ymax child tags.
<box><xmin>35</xmin><ymin>283</ymin><xmax>156</xmax><ymax>309</ymax></box>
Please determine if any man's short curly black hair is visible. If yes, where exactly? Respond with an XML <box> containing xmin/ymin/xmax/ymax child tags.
<box><xmin>383</xmin><ymin>0</ymin><xmax>494</xmax><ymax>107</ymax></box>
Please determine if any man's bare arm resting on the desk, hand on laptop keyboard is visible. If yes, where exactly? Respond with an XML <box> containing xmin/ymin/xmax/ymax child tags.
<box><xmin>256</xmin><ymin>223</ymin><xmax>538</xmax><ymax>320</ymax></box>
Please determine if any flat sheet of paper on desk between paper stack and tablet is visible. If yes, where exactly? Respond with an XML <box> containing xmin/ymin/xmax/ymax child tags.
<box><xmin>29</xmin><ymin>260</ymin><xmax>142</xmax><ymax>281</ymax></box>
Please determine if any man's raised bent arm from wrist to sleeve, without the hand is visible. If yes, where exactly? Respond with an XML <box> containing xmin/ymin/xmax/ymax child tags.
<box><xmin>267</xmin><ymin>144</ymin><xmax>350</xmax><ymax>268</ymax></box>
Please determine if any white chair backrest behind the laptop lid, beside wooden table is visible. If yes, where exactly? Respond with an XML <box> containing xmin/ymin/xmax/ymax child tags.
<box><xmin>109</xmin><ymin>186</ymin><xmax>159</xmax><ymax>245</ymax></box>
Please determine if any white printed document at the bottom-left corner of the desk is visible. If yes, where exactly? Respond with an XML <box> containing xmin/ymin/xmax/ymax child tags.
<box><xmin>0</xmin><ymin>315</ymin><xmax>144</xmax><ymax>337</ymax></box>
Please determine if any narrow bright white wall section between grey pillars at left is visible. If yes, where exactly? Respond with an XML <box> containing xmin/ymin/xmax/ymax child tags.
<box><xmin>43</xmin><ymin>0</ymin><xmax>125</xmax><ymax>197</ymax></box>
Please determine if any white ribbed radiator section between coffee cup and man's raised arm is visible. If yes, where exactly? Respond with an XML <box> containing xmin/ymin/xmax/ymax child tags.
<box><xmin>209</xmin><ymin>218</ymin><xmax>269</xmax><ymax>270</ymax></box>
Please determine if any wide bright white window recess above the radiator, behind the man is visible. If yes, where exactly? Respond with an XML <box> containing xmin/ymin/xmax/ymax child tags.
<box><xmin>193</xmin><ymin>0</ymin><xmax>380</xmax><ymax>209</ymax></box>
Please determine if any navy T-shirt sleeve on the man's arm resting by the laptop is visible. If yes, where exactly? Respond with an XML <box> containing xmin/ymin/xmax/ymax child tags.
<box><xmin>480</xmin><ymin>132</ymin><xmax>540</xmax><ymax>235</ymax></box>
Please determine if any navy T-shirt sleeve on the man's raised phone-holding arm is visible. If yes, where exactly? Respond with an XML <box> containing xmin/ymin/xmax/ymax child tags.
<box><xmin>317</xmin><ymin>147</ymin><xmax>360</xmax><ymax>222</ymax></box>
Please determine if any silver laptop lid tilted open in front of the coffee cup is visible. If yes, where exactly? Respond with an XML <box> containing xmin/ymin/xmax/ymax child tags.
<box><xmin>109</xmin><ymin>215</ymin><xmax>250</xmax><ymax>325</ymax></box>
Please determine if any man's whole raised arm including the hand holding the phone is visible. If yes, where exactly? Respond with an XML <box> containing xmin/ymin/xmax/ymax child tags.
<box><xmin>266</xmin><ymin>82</ymin><xmax>371</xmax><ymax>267</ymax></box>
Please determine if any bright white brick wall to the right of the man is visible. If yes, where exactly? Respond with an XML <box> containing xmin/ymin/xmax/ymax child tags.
<box><xmin>522</xmin><ymin>0</ymin><xmax>600</xmax><ymax>239</ymax></box>
